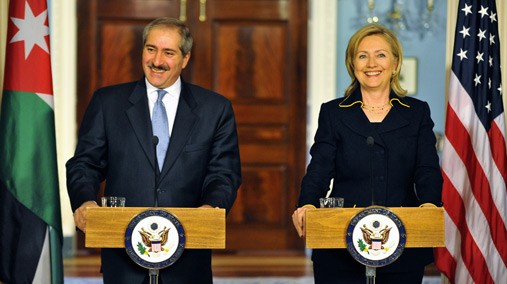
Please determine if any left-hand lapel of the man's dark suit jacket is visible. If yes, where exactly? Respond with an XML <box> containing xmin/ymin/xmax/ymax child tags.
<box><xmin>126</xmin><ymin>78</ymin><xmax>155</xmax><ymax>169</ymax></box>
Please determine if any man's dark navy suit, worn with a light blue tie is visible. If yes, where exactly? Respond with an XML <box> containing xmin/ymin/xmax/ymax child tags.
<box><xmin>67</xmin><ymin>78</ymin><xmax>241</xmax><ymax>283</ymax></box>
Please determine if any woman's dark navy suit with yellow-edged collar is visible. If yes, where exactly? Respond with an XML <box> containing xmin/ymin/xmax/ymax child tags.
<box><xmin>298</xmin><ymin>90</ymin><xmax>443</xmax><ymax>278</ymax></box>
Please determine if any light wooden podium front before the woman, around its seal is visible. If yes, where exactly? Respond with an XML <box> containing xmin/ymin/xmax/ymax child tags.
<box><xmin>306</xmin><ymin>207</ymin><xmax>445</xmax><ymax>249</ymax></box>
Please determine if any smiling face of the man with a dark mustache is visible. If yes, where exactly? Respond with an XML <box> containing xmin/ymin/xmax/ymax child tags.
<box><xmin>142</xmin><ymin>27</ymin><xmax>190</xmax><ymax>89</ymax></box>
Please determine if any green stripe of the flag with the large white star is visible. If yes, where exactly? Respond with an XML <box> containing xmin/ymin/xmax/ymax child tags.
<box><xmin>0</xmin><ymin>90</ymin><xmax>62</xmax><ymax>235</ymax></box>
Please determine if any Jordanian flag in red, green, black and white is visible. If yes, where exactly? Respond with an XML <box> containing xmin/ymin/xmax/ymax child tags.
<box><xmin>0</xmin><ymin>0</ymin><xmax>63</xmax><ymax>283</ymax></box>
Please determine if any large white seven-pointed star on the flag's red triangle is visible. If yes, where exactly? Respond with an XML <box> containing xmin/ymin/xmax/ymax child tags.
<box><xmin>10</xmin><ymin>2</ymin><xmax>49</xmax><ymax>59</ymax></box>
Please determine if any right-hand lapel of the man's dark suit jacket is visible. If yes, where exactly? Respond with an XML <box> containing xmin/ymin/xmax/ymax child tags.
<box><xmin>161</xmin><ymin>81</ymin><xmax>199</xmax><ymax>178</ymax></box>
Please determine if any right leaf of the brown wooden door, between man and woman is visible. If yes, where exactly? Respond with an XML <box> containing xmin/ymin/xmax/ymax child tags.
<box><xmin>192</xmin><ymin>0</ymin><xmax>307</xmax><ymax>250</ymax></box>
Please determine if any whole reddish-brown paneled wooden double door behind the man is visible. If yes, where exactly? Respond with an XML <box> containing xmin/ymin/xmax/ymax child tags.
<box><xmin>78</xmin><ymin>0</ymin><xmax>307</xmax><ymax>250</ymax></box>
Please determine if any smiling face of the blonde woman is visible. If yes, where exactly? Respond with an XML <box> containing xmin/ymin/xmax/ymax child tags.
<box><xmin>353</xmin><ymin>35</ymin><xmax>397</xmax><ymax>91</ymax></box>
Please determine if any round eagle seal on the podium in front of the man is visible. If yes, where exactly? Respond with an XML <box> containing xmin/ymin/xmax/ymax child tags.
<box><xmin>125</xmin><ymin>210</ymin><xmax>185</xmax><ymax>269</ymax></box>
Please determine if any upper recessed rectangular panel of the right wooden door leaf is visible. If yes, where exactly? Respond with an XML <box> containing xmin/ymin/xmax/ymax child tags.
<box><xmin>213</xmin><ymin>22</ymin><xmax>287</xmax><ymax>101</ymax></box>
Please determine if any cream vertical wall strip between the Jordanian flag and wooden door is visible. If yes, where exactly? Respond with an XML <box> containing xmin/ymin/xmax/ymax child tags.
<box><xmin>49</xmin><ymin>0</ymin><xmax>77</xmax><ymax>236</ymax></box>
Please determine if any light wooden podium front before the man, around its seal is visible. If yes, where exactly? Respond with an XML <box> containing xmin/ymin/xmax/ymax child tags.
<box><xmin>85</xmin><ymin>207</ymin><xmax>225</xmax><ymax>249</ymax></box>
